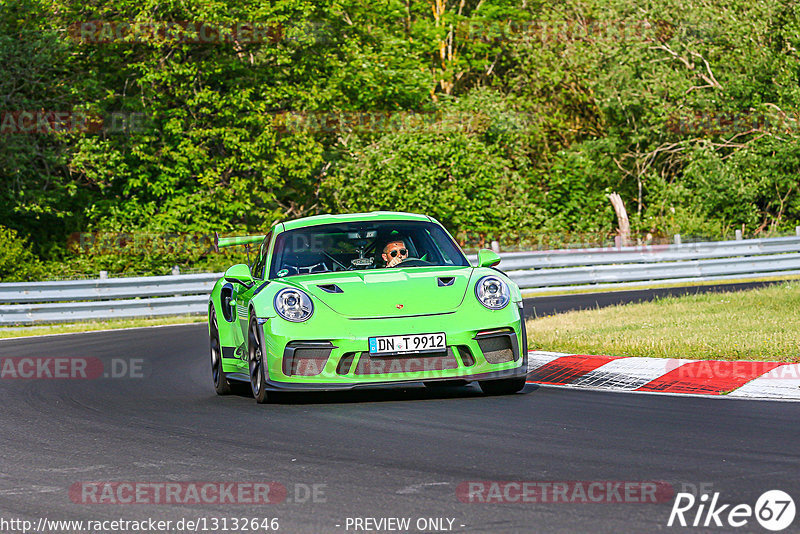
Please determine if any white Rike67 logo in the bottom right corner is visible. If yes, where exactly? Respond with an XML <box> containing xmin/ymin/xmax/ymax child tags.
<box><xmin>667</xmin><ymin>490</ymin><xmax>795</xmax><ymax>532</ymax></box>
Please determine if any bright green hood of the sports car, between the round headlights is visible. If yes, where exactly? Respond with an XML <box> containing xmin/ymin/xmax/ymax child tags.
<box><xmin>285</xmin><ymin>267</ymin><xmax>472</xmax><ymax>318</ymax></box>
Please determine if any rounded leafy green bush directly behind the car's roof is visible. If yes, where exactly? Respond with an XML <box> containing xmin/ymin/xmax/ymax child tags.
<box><xmin>320</xmin><ymin>91</ymin><xmax>534</xmax><ymax>242</ymax></box>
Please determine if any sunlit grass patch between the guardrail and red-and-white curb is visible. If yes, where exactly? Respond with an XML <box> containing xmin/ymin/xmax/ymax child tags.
<box><xmin>527</xmin><ymin>282</ymin><xmax>800</xmax><ymax>362</ymax></box>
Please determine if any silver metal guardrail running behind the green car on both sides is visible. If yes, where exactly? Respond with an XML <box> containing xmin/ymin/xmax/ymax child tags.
<box><xmin>0</xmin><ymin>236</ymin><xmax>800</xmax><ymax>326</ymax></box>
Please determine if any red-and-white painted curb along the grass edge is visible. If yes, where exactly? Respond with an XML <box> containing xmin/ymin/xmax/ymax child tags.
<box><xmin>528</xmin><ymin>351</ymin><xmax>800</xmax><ymax>400</ymax></box>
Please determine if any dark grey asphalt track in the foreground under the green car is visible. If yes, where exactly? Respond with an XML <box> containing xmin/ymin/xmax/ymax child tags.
<box><xmin>0</xmin><ymin>325</ymin><xmax>800</xmax><ymax>533</ymax></box>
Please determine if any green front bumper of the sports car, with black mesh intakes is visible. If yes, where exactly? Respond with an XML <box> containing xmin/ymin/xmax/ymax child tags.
<box><xmin>250</xmin><ymin>305</ymin><xmax>528</xmax><ymax>391</ymax></box>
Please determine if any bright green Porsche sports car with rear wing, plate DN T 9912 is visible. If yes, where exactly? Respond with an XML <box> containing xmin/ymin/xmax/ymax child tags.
<box><xmin>208</xmin><ymin>212</ymin><xmax>528</xmax><ymax>403</ymax></box>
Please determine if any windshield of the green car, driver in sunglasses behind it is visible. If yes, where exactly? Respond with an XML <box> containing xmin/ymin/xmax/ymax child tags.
<box><xmin>269</xmin><ymin>221</ymin><xmax>469</xmax><ymax>278</ymax></box>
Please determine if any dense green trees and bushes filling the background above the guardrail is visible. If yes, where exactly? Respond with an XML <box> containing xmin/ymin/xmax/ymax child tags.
<box><xmin>0</xmin><ymin>0</ymin><xmax>800</xmax><ymax>282</ymax></box>
